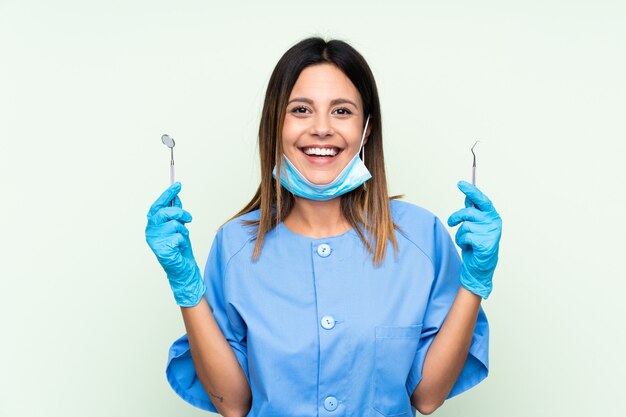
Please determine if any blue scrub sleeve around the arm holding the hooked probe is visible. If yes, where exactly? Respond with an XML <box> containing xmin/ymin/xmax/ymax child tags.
<box><xmin>406</xmin><ymin>217</ymin><xmax>489</xmax><ymax>399</ymax></box>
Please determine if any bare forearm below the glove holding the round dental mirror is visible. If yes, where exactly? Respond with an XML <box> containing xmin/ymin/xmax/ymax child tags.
<box><xmin>181</xmin><ymin>297</ymin><xmax>252</xmax><ymax>417</ymax></box>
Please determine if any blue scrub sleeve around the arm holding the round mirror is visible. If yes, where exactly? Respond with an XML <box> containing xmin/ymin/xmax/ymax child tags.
<box><xmin>165</xmin><ymin>229</ymin><xmax>250</xmax><ymax>413</ymax></box>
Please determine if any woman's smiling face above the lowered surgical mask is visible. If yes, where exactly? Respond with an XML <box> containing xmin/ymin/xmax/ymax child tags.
<box><xmin>282</xmin><ymin>64</ymin><xmax>369</xmax><ymax>184</ymax></box>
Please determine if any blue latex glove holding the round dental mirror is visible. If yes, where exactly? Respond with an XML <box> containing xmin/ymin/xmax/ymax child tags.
<box><xmin>146</xmin><ymin>181</ymin><xmax>206</xmax><ymax>307</ymax></box>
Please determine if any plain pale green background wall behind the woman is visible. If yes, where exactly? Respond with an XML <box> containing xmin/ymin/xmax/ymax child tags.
<box><xmin>0</xmin><ymin>0</ymin><xmax>626</xmax><ymax>417</ymax></box>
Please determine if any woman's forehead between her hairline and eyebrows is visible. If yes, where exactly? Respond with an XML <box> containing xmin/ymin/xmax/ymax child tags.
<box><xmin>290</xmin><ymin>64</ymin><xmax>361</xmax><ymax>103</ymax></box>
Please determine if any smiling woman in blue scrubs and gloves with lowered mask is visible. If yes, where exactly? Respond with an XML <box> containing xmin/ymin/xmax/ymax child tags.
<box><xmin>146</xmin><ymin>38</ymin><xmax>501</xmax><ymax>417</ymax></box>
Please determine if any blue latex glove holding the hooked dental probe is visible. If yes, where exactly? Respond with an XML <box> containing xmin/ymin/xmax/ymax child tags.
<box><xmin>448</xmin><ymin>181</ymin><xmax>502</xmax><ymax>300</ymax></box>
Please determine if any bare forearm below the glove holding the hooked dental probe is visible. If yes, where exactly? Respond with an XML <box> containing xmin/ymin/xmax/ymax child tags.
<box><xmin>411</xmin><ymin>286</ymin><xmax>481</xmax><ymax>414</ymax></box>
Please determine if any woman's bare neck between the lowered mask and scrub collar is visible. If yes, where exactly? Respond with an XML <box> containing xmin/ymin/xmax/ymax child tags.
<box><xmin>284</xmin><ymin>196</ymin><xmax>352</xmax><ymax>238</ymax></box>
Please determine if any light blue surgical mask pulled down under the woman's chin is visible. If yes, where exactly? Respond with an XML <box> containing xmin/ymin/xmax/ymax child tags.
<box><xmin>272</xmin><ymin>116</ymin><xmax>372</xmax><ymax>201</ymax></box>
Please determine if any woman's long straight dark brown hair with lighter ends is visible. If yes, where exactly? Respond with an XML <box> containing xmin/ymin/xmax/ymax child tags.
<box><xmin>222</xmin><ymin>37</ymin><xmax>403</xmax><ymax>266</ymax></box>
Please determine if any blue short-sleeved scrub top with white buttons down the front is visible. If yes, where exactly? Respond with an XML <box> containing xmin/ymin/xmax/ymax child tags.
<box><xmin>166</xmin><ymin>200</ymin><xmax>489</xmax><ymax>417</ymax></box>
